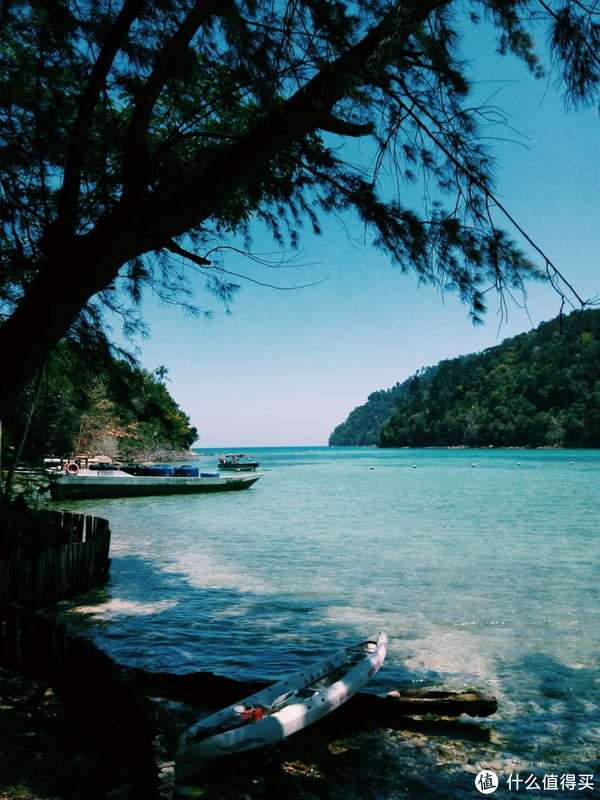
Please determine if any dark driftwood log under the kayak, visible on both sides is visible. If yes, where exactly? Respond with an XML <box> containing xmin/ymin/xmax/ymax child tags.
<box><xmin>131</xmin><ymin>669</ymin><xmax>498</xmax><ymax>725</ymax></box>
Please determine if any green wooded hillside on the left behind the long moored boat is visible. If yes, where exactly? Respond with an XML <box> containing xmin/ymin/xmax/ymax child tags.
<box><xmin>5</xmin><ymin>341</ymin><xmax>198</xmax><ymax>462</ymax></box>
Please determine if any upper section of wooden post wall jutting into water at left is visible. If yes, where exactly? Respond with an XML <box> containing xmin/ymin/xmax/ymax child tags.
<box><xmin>0</xmin><ymin>511</ymin><xmax>110</xmax><ymax>608</ymax></box>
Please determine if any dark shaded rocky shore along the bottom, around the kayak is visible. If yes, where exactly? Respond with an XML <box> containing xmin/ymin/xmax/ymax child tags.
<box><xmin>0</xmin><ymin>609</ymin><xmax>497</xmax><ymax>800</ymax></box>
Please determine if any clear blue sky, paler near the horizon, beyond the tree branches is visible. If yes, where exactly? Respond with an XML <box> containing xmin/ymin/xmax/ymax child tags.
<box><xmin>113</xmin><ymin>15</ymin><xmax>600</xmax><ymax>449</ymax></box>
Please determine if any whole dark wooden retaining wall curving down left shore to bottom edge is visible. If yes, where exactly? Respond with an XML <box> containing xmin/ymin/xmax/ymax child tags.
<box><xmin>0</xmin><ymin>511</ymin><xmax>162</xmax><ymax>800</ymax></box>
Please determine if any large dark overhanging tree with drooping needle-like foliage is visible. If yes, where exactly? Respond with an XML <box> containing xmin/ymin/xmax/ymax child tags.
<box><xmin>0</xmin><ymin>0</ymin><xmax>600</xmax><ymax>417</ymax></box>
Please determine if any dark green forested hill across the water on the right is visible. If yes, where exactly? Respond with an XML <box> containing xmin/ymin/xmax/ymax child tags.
<box><xmin>329</xmin><ymin>309</ymin><xmax>600</xmax><ymax>447</ymax></box>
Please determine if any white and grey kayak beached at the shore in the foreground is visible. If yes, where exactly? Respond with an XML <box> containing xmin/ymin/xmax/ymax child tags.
<box><xmin>175</xmin><ymin>632</ymin><xmax>387</xmax><ymax>783</ymax></box>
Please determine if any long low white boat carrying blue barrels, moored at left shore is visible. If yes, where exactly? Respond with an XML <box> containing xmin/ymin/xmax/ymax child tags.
<box><xmin>50</xmin><ymin>461</ymin><xmax>261</xmax><ymax>500</ymax></box>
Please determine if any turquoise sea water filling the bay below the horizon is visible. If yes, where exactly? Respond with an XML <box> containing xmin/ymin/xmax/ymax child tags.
<box><xmin>58</xmin><ymin>448</ymin><xmax>600</xmax><ymax>797</ymax></box>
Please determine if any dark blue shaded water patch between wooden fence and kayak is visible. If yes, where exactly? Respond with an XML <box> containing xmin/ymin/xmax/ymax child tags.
<box><xmin>60</xmin><ymin>555</ymin><xmax>439</xmax><ymax>680</ymax></box>
